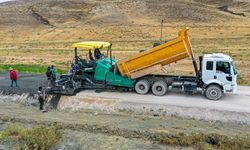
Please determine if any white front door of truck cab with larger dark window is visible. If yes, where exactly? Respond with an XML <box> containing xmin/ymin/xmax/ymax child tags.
<box><xmin>214</xmin><ymin>61</ymin><xmax>233</xmax><ymax>92</ymax></box>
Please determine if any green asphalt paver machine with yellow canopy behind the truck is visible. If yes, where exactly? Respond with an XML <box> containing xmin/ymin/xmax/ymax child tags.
<box><xmin>48</xmin><ymin>41</ymin><xmax>134</xmax><ymax>95</ymax></box>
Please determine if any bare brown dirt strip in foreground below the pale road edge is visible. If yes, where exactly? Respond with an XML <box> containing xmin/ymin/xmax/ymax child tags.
<box><xmin>0</xmin><ymin>103</ymin><xmax>250</xmax><ymax>149</ymax></box>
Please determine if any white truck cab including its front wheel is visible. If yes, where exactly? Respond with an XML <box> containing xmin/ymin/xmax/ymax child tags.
<box><xmin>201</xmin><ymin>53</ymin><xmax>237</xmax><ymax>100</ymax></box>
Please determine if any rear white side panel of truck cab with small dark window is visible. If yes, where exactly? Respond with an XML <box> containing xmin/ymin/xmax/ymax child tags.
<box><xmin>202</xmin><ymin>60</ymin><xmax>215</xmax><ymax>83</ymax></box>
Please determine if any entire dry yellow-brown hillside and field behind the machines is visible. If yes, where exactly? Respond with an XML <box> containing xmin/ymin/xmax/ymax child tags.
<box><xmin>0</xmin><ymin>0</ymin><xmax>250</xmax><ymax>84</ymax></box>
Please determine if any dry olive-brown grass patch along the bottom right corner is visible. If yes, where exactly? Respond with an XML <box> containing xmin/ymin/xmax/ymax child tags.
<box><xmin>161</xmin><ymin>133</ymin><xmax>250</xmax><ymax>150</ymax></box>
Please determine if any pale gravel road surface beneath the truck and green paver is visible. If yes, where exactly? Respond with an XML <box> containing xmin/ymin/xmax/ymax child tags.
<box><xmin>73</xmin><ymin>86</ymin><xmax>250</xmax><ymax>113</ymax></box>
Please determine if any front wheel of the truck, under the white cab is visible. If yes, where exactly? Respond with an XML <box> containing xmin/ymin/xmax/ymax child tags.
<box><xmin>205</xmin><ymin>85</ymin><xmax>222</xmax><ymax>101</ymax></box>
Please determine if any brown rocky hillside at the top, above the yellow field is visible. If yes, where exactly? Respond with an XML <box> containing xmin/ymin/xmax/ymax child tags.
<box><xmin>0</xmin><ymin>0</ymin><xmax>250</xmax><ymax>27</ymax></box>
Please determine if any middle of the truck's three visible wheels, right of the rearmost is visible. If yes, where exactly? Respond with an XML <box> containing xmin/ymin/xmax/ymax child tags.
<box><xmin>152</xmin><ymin>80</ymin><xmax>167</xmax><ymax>96</ymax></box>
